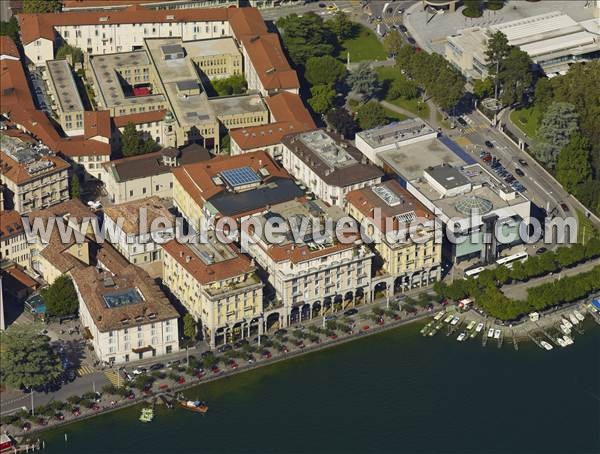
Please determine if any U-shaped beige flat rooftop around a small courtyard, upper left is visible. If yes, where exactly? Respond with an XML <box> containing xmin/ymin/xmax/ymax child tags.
<box><xmin>90</xmin><ymin>50</ymin><xmax>166</xmax><ymax>108</ymax></box>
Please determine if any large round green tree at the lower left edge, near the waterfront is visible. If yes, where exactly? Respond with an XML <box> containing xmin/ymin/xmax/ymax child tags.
<box><xmin>0</xmin><ymin>324</ymin><xmax>63</xmax><ymax>388</ymax></box>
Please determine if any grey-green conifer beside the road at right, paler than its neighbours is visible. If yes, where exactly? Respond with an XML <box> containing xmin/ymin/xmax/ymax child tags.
<box><xmin>532</xmin><ymin>102</ymin><xmax>578</xmax><ymax>168</ymax></box>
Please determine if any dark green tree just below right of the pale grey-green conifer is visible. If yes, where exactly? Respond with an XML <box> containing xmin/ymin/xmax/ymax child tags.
<box><xmin>556</xmin><ymin>133</ymin><xmax>592</xmax><ymax>193</ymax></box>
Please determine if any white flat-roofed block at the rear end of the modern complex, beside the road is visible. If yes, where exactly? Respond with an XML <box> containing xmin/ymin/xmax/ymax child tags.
<box><xmin>355</xmin><ymin>118</ymin><xmax>438</xmax><ymax>167</ymax></box>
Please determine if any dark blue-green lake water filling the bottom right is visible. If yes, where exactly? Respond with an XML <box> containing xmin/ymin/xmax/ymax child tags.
<box><xmin>43</xmin><ymin>325</ymin><xmax>600</xmax><ymax>454</ymax></box>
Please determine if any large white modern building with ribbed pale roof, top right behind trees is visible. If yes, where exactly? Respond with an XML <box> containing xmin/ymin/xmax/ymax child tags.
<box><xmin>445</xmin><ymin>11</ymin><xmax>600</xmax><ymax>79</ymax></box>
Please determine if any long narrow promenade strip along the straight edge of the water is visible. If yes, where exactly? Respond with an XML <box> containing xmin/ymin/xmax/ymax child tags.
<box><xmin>12</xmin><ymin>307</ymin><xmax>436</xmax><ymax>442</ymax></box>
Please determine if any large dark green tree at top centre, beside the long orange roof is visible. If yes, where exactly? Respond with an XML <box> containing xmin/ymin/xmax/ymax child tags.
<box><xmin>277</xmin><ymin>12</ymin><xmax>337</xmax><ymax>66</ymax></box>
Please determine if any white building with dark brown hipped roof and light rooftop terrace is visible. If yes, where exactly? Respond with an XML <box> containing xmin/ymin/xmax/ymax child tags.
<box><xmin>282</xmin><ymin>129</ymin><xmax>383</xmax><ymax>207</ymax></box>
